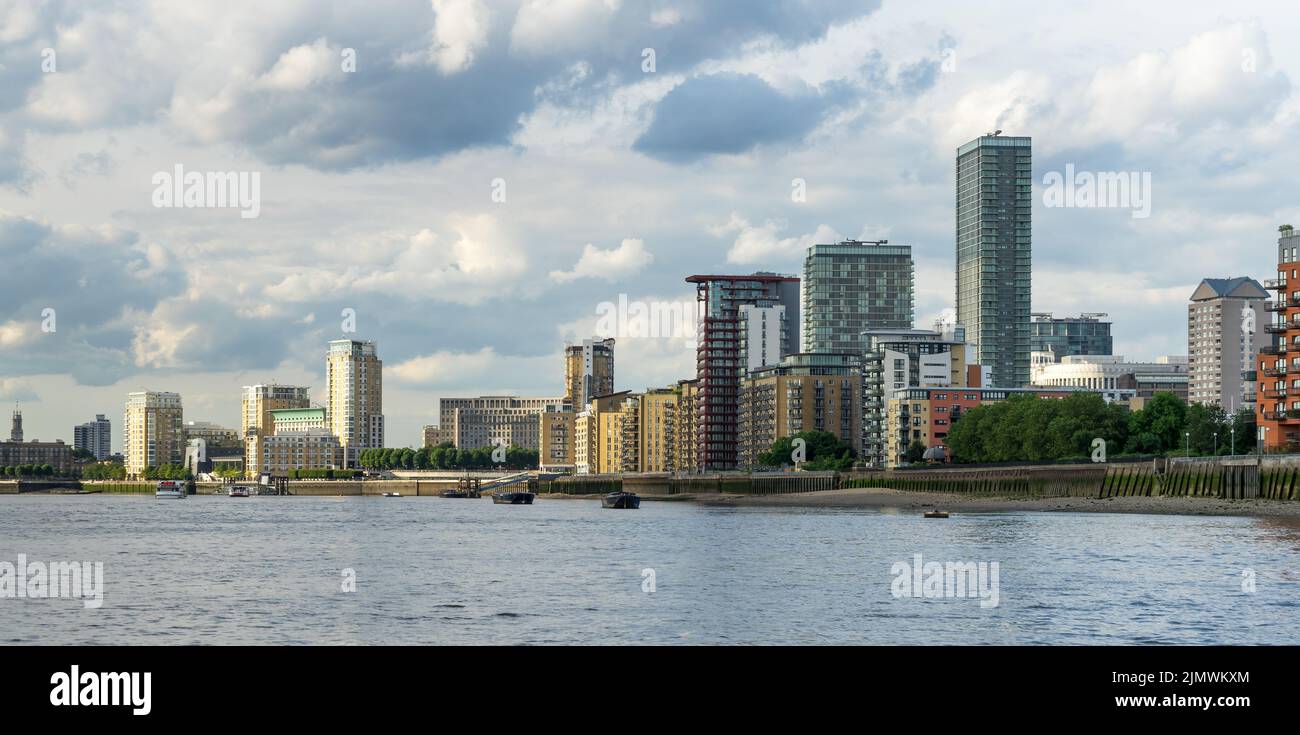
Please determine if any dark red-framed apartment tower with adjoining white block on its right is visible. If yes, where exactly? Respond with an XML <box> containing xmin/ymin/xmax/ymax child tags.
<box><xmin>686</xmin><ymin>273</ymin><xmax>800</xmax><ymax>470</ymax></box>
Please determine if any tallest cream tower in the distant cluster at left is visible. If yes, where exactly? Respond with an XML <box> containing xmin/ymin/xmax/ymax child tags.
<box><xmin>325</xmin><ymin>340</ymin><xmax>384</xmax><ymax>467</ymax></box>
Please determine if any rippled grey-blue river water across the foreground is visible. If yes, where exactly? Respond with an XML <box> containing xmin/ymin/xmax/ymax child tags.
<box><xmin>0</xmin><ymin>496</ymin><xmax>1300</xmax><ymax>644</ymax></box>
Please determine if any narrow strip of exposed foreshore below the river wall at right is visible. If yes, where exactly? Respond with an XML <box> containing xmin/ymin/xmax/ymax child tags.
<box><xmin>686</xmin><ymin>488</ymin><xmax>1300</xmax><ymax>520</ymax></box>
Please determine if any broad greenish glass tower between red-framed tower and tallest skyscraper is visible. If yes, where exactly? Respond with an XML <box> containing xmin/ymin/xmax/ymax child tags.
<box><xmin>803</xmin><ymin>239</ymin><xmax>914</xmax><ymax>354</ymax></box>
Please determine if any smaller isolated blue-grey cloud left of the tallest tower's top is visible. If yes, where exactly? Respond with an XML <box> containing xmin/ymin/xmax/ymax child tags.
<box><xmin>633</xmin><ymin>74</ymin><xmax>835</xmax><ymax>163</ymax></box>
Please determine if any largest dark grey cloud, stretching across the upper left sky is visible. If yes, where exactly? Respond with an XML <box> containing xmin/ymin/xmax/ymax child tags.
<box><xmin>0</xmin><ymin>0</ymin><xmax>879</xmax><ymax>178</ymax></box>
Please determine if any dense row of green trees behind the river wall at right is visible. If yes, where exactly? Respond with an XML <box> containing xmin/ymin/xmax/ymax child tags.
<box><xmin>946</xmin><ymin>392</ymin><xmax>1256</xmax><ymax>462</ymax></box>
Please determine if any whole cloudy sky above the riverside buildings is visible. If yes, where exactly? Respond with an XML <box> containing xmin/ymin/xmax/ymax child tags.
<box><xmin>0</xmin><ymin>0</ymin><xmax>1300</xmax><ymax>449</ymax></box>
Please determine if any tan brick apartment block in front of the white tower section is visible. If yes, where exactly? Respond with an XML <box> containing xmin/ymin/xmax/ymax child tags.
<box><xmin>737</xmin><ymin>353</ymin><xmax>862</xmax><ymax>470</ymax></box>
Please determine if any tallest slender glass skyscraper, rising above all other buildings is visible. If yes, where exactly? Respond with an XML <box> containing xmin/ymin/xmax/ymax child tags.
<box><xmin>957</xmin><ymin>133</ymin><xmax>1034</xmax><ymax>388</ymax></box>
